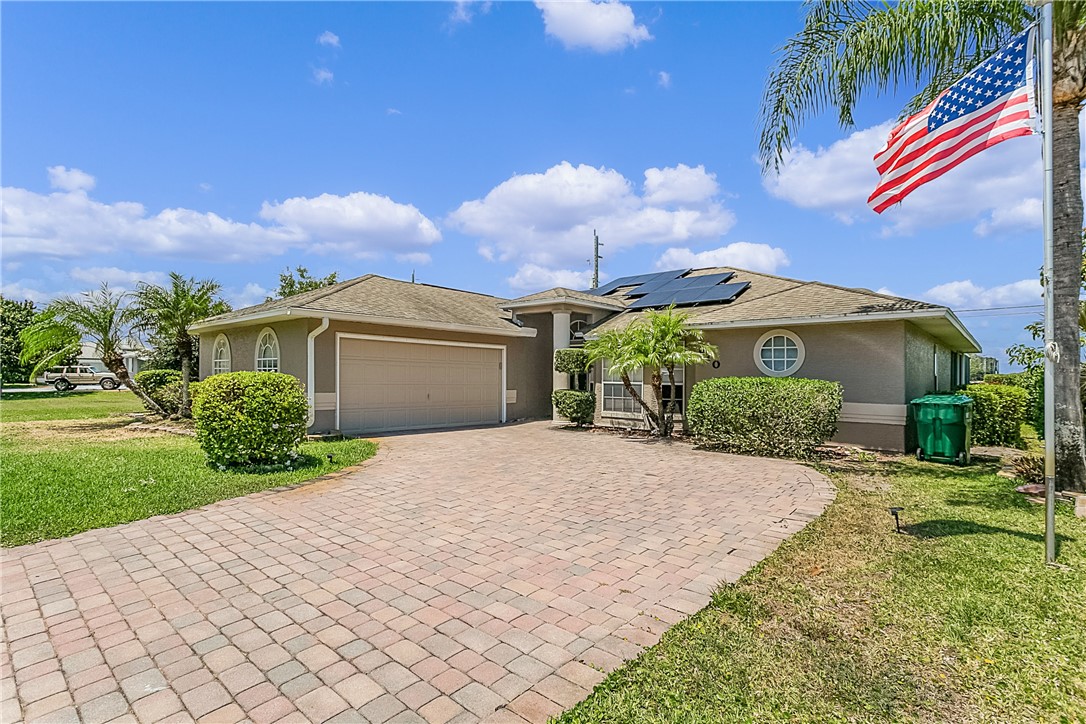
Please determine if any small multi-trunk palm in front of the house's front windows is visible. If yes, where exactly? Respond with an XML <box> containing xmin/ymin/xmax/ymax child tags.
<box><xmin>584</xmin><ymin>306</ymin><xmax>717</xmax><ymax>437</ymax></box>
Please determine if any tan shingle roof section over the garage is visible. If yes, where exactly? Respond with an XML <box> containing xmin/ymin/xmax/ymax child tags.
<box><xmin>201</xmin><ymin>274</ymin><xmax>517</xmax><ymax>330</ymax></box>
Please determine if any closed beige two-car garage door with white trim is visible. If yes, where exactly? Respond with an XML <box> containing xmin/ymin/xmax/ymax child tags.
<box><xmin>339</xmin><ymin>338</ymin><xmax>503</xmax><ymax>433</ymax></box>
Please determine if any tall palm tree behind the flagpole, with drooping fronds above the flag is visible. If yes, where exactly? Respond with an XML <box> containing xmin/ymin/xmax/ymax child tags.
<box><xmin>760</xmin><ymin>0</ymin><xmax>1086</xmax><ymax>491</ymax></box>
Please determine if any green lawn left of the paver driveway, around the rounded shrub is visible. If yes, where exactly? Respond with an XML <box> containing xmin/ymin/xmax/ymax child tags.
<box><xmin>0</xmin><ymin>392</ymin><xmax>377</xmax><ymax>546</ymax></box>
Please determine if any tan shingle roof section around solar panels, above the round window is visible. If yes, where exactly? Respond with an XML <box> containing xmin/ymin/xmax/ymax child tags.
<box><xmin>593</xmin><ymin>267</ymin><xmax>944</xmax><ymax>331</ymax></box>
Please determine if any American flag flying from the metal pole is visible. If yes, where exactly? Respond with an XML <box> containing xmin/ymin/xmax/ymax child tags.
<box><xmin>868</xmin><ymin>28</ymin><xmax>1037</xmax><ymax>214</ymax></box>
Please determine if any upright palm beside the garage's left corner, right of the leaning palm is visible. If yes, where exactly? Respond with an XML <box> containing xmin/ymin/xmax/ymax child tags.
<box><xmin>136</xmin><ymin>271</ymin><xmax>230</xmax><ymax>417</ymax></box>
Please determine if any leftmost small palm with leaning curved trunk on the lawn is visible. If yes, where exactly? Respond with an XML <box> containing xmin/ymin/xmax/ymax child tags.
<box><xmin>20</xmin><ymin>282</ymin><xmax>165</xmax><ymax>415</ymax></box>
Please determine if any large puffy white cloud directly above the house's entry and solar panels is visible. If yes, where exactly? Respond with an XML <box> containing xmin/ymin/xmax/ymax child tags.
<box><xmin>447</xmin><ymin>162</ymin><xmax>735</xmax><ymax>269</ymax></box>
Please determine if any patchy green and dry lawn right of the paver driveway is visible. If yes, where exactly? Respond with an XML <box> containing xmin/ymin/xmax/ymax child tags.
<box><xmin>558</xmin><ymin>459</ymin><xmax>1086</xmax><ymax>724</ymax></box>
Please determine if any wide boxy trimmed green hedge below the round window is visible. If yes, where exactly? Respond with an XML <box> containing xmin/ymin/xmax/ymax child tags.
<box><xmin>686</xmin><ymin>377</ymin><xmax>843</xmax><ymax>458</ymax></box>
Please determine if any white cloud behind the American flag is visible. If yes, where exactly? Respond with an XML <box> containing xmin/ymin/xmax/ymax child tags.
<box><xmin>762</xmin><ymin>116</ymin><xmax>1077</xmax><ymax>236</ymax></box>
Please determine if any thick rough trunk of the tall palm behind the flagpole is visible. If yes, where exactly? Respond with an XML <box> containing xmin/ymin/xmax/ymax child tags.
<box><xmin>1046</xmin><ymin>102</ymin><xmax>1086</xmax><ymax>492</ymax></box>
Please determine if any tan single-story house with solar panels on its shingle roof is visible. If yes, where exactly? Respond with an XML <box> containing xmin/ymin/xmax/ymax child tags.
<box><xmin>193</xmin><ymin>268</ymin><xmax>980</xmax><ymax>450</ymax></box>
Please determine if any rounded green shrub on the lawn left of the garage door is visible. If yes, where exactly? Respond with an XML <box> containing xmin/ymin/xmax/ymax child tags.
<box><xmin>192</xmin><ymin>372</ymin><xmax>308</xmax><ymax>468</ymax></box>
